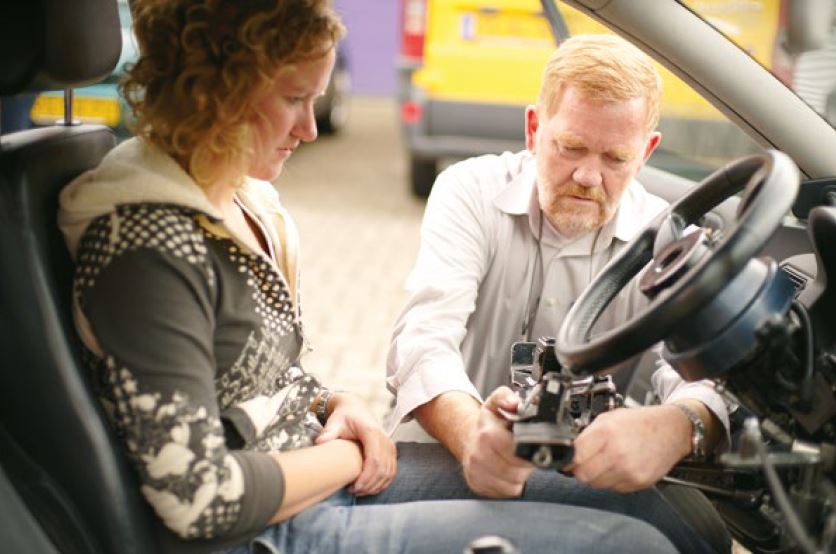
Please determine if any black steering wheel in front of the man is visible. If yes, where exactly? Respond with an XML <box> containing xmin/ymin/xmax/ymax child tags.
<box><xmin>555</xmin><ymin>150</ymin><xmax>800</xmax><ymax>376</ymax></box>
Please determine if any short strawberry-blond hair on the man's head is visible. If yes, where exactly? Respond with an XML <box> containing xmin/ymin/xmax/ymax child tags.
<box><xmin>537</xmin><ymin>35</ymin><xmax>662</xmax><ymax>133</ymax></box>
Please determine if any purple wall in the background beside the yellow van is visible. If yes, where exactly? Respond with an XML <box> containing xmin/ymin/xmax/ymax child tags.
<box><xmin>335</xmin><ymin>0</ymin><xmax>400</xmax><ymax>95</ymax></box>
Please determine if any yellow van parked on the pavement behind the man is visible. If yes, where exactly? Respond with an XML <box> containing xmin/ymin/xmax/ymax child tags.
<box><xmin>399</xmin><ymin>0</ymin><xmax>789</xmax><ymax>196</ymax></box>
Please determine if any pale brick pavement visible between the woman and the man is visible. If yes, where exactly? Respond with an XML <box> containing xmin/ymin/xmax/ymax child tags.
<box><xmin>276</xmin><ymin>97</ymin><xmax>424</xmax><ymax>417</ymax></box>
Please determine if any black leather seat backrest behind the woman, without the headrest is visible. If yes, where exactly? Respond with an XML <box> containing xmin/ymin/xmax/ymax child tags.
<box><xmin>0</xmin><ymin>126</ymin><xmax>165</xmax><ymax>553</ymax></box>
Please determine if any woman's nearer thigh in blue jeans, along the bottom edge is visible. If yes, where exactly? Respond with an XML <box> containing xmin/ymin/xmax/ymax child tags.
<box><xmin>230</xmin><ymin>490</ymin><xmax>676</xmax><ymax>554</ymax></box>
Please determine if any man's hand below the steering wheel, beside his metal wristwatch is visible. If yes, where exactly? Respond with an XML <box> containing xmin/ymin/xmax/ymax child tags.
<box><xmin>567</xmin><ymin>406</ymin><xmax>691</xmax><ymax>492</ymax></box>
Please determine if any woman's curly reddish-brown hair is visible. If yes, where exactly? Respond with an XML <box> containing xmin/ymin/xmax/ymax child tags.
<box><xmin>120</xmin><ymin>0</ymin><xmax>345</xmax><ymax>186</ymax></box>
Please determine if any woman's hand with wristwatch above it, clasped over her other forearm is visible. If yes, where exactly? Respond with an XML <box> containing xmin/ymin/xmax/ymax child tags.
<box><xmin>316</xmin><ymin>393</ymin><xmax>398</xmax><ymax>496</ymax></box>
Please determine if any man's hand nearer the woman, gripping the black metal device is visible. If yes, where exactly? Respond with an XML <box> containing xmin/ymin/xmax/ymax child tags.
<box><xmin>461</xmin><ymin>387</ymin><xmax>534</xmax><ymax>498</ymax></box>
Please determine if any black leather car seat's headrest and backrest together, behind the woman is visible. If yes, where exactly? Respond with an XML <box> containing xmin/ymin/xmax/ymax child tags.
<box><xmin>0</xmin><ymin>0</ymin><xmax>167</xmax><ymax>554</ymax></box>
